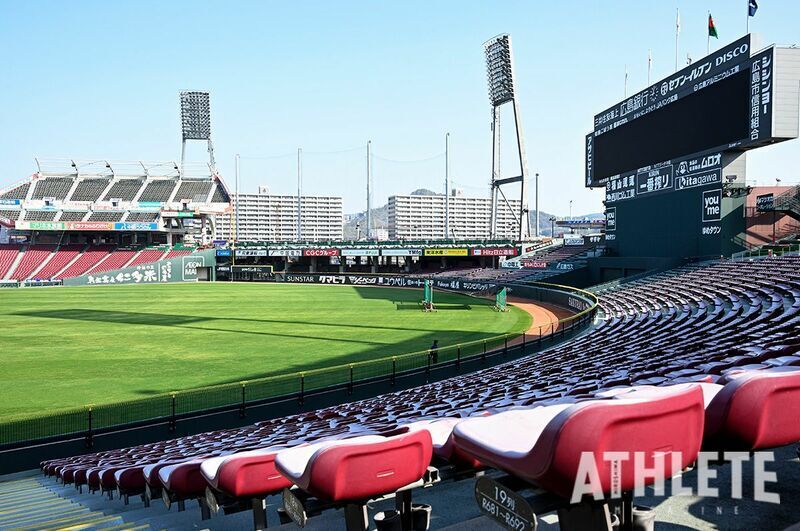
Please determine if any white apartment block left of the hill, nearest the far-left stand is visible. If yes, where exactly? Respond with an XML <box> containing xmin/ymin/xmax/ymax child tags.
<box><xmin>214</xmin><ymin>190</ymin><xmax>343</xmax><ymax>241</ymax></box>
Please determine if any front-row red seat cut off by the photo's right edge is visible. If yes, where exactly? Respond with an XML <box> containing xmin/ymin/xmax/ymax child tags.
<box><xmin>704</xmin><ymin>366</ymin><xmax>800</xmax><ymax>450</ymax></box>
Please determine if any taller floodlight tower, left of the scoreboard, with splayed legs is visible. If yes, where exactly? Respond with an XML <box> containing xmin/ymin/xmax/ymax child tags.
<box><xmin>483</xmin><ymin>33</ymin><xmax>529</xmax><ymax>240</ymax></box>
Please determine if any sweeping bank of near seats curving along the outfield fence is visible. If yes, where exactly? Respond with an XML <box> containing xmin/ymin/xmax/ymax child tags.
<box><xmin>34</xmin><ymin>256</ymin><xmax>800</xmax><ymax>528</ymax></box>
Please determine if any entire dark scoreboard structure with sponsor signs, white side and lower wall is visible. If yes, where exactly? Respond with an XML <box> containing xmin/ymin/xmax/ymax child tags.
<box><xmin>585</xmin><ymin>35</ymin><xmax>800</xmax><ymax>258</ymax></box>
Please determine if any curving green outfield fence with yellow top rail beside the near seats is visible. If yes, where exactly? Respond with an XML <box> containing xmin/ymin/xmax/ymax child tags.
<box><xmin>0</xmin><ymin>284</ymin><xmax>598</xmax><ymax>448</ymax></box>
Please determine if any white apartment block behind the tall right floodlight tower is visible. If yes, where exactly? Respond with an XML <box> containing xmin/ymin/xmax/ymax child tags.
<box><xmin>389</xmin><ymin>195</ymin><xmax>520</xmax><ymax>240</ymax></box>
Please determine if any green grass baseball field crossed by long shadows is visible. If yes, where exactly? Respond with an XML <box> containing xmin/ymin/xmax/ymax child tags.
<box><xmin>0</xmin><ymin>283</ymin><xmax>531</xmax><ymax>421</ymax></box>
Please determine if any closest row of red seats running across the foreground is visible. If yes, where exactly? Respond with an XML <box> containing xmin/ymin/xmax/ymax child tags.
<box><xmin>42</xmin><ymin>367</ymin><xmax>800</xmax><ymax>526</ymax></box>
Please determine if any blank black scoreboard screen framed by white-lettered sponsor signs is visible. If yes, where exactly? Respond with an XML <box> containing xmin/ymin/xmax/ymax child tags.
<box><xmin>585</xmin><ymin>35</ymin><xmax>774</xmax><ymax>187</ymax></box>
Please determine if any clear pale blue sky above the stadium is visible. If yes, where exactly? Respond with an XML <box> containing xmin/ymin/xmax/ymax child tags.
<box><xmin>0</xmin><ymin>0</ymin><xmax>800</xmax><ymax>215</ymax></box>
